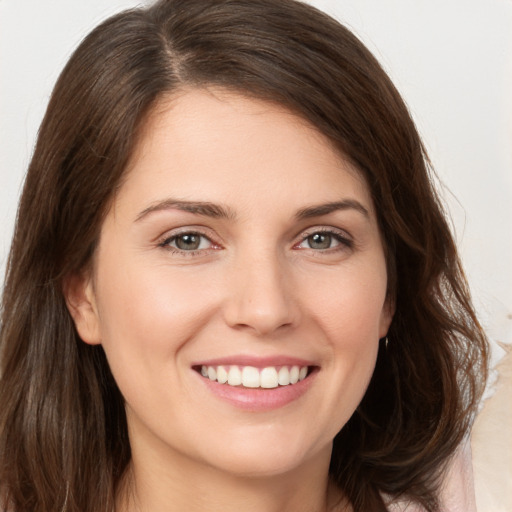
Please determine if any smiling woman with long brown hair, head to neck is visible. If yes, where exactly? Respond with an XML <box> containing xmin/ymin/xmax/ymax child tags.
<box><xmin>0</xmin><ymin>0</ymin><xmax>486</xmax><ymax>512</ymax></box>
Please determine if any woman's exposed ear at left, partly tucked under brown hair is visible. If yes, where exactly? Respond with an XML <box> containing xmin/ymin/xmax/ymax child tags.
<box><xmin>62</xmin><ymin>272</ymin><xmax>101</xmax><ymax>345</ymax></box>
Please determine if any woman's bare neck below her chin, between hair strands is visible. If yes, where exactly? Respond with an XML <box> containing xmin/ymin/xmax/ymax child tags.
<box><xmin>116</xmin><ymin>438</ymin><xmax>350</xmax><ymax>512</ymax></box>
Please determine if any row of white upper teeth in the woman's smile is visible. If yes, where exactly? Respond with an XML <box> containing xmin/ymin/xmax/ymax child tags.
<box><xmin>201</xmin><ymin>366</ymin><xmax>308</xmax><ymax>389</ymax></box>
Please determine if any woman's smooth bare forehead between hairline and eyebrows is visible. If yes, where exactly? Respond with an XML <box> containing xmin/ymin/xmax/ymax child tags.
<box><xmin>118</xmin><ymin>85</ymin><xmax>372</xmax><ymax>216</ymax></box>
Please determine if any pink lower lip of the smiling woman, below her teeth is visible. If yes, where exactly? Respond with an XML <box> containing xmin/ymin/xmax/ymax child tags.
<box><xmin>198</xmin><ymin>371</ymin><xmax>317</xmax><ymax>412</ymax></box>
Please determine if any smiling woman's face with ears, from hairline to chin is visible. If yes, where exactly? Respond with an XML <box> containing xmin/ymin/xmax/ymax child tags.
<box><xmin>68</xmin><ymin>90</ymin><xmax>391</xmax><ymax>475</ymax></box>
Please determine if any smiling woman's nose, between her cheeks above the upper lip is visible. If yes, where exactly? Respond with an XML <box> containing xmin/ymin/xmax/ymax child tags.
<box><xmin>224</xmin><ymin>251</ymin><xmax>299</xmax><ymax>337</ymax></box>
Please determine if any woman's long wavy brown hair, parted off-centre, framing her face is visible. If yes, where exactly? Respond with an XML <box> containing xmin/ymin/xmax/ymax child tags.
<box><xmin>0</xmin><ymin>0</ymin><xmax>487</xmax><ymax>512</ymax></box>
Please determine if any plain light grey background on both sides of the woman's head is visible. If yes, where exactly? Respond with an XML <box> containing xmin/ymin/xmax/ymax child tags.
<box><xmin>0</xmin><ymin>0</ymin><xmax>512</xmax><ymax>352</ymax></box>
